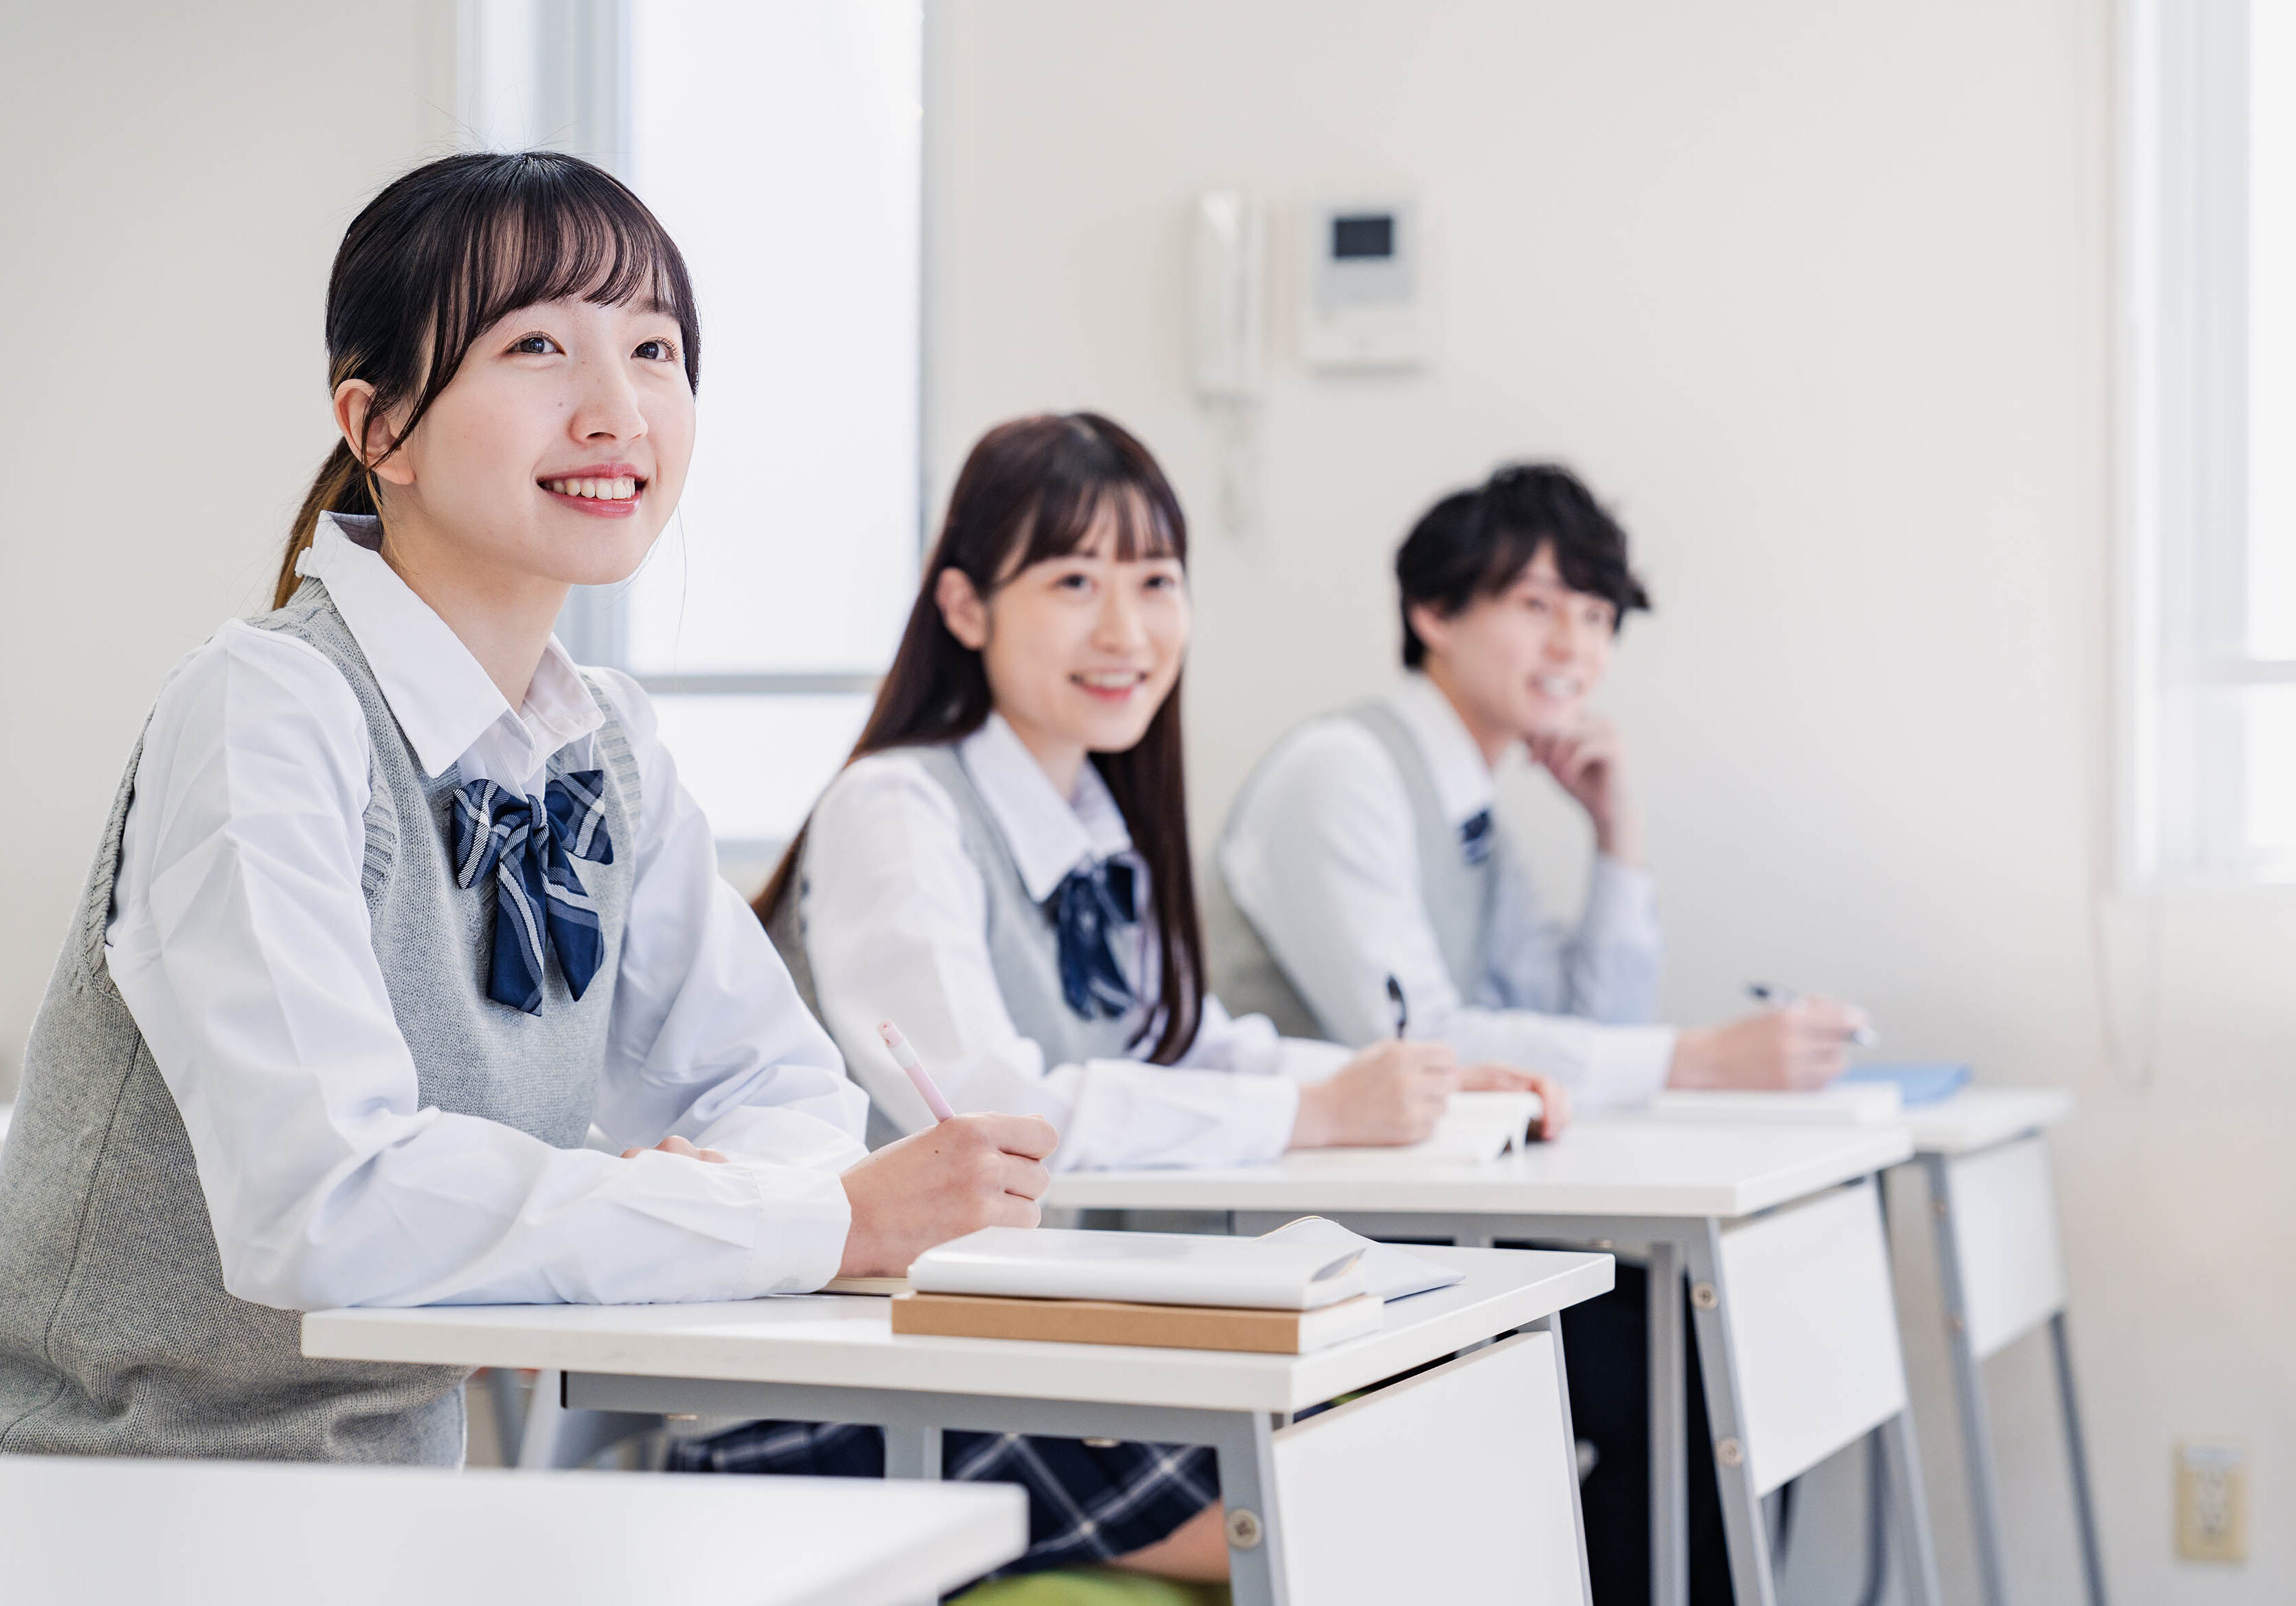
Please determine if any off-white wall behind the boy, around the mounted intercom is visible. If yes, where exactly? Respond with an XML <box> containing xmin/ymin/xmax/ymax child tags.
<box><xmin>928</xmin><ymin>0</ymin><xmax>2296</xmax><ymax>1601</ymax></box>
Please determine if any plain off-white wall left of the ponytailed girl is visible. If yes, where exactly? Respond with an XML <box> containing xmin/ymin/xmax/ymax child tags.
<box><xmin>0</xmin><ymin>0</ymin><xmax>452</xmax><ymax>1096</ymax></box>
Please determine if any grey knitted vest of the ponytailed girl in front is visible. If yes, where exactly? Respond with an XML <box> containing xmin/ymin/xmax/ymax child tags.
<box><xmin>0</xmin><ymin>579</ymin><xmax>638</xmax><ymax>1466</ymax></box>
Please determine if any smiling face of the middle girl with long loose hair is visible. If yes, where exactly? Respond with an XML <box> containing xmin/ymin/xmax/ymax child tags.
<box><xmin>939</xmin><ymin>496</ymin><xmax>1191</xmax><ymax>790</ymax></box>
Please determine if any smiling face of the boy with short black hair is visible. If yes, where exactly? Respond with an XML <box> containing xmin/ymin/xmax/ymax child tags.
<box><xmin>1412</xmin><ymin>545</ymin><xmax>1619</xmax><ymax>737</ymax></box>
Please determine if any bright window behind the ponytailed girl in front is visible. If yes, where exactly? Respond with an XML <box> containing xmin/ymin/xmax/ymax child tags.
<box><xmin>464</xmin><ymin>0</ymin><xmax>923</xmax><ymax>857</ymax></box>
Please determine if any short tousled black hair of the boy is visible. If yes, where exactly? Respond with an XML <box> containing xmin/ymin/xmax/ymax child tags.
<box><xmin>1396</xmin><ymin>462</ymin><xmax>1651</xmax><ymax>668</ymax></box>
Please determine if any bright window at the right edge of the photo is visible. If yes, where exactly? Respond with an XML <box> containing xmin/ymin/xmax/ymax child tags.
<box><xmin>2124</xmin><ymin>0</ymin><xmax>2296</xmax><ymax>883</ymax></box>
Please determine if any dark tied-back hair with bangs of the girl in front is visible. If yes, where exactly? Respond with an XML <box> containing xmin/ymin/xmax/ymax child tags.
<box><xmin>271</xmin><ymin>151</ymin><xmax>703</xmax><ymax>606</ymax></box>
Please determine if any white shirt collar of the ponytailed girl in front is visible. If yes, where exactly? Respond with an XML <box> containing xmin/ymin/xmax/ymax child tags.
<box><xmin>294</xmin><ymin>512</ymin><xmax>606</xmax><ymax>774</ymax></box>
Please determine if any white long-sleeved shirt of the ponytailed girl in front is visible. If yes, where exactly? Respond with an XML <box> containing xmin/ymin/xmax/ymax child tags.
<box><xmin>105</xmin><ymin>519</ymin><xmax>866</xmax><ymax>1309</ymax></box>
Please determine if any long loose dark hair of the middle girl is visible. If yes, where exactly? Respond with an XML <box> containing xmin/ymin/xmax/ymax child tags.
<box><xmin>756</xmin><ymin>414</ymin><xmax>1203</xmax><ymax>1064</ymax></box>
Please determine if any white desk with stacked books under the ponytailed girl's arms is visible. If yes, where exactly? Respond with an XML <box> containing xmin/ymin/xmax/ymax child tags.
<box><xmin>303</xmin><ymin>1250</ymin><xmax>1612</xmax><ymax>1606</ymax></box>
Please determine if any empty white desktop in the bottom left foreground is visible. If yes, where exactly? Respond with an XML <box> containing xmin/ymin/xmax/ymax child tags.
<box><xmin>0</xmin><ymin>1455</ymin><xmax>1029</xmax><ymax>1606</ymax></box>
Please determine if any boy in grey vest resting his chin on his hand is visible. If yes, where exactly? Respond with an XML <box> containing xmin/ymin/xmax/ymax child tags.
<box><xmin>1212</xmin><ymin>464</ymin><xmax>1864</xmax><ymax>1601</ymax></box>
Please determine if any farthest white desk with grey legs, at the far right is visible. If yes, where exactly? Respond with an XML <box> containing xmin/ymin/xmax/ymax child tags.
<box><xmin>1906</xmin><ymin>1087</ymin><xmax>2105</xmax><ymax>1606</ymax></box>
